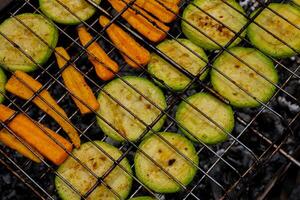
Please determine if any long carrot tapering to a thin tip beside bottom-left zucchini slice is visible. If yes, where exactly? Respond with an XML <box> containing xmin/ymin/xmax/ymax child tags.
<box><xmin>5</xmin><ymin>71</ymin><xmax>80</xmax><ymax>148</ymax></box>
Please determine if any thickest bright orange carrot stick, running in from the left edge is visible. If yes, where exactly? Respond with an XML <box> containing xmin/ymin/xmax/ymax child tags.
<box><xmin>0</xmin><ymin>104</ymin><xmax>72</xmax><ymax>165</ymax></box>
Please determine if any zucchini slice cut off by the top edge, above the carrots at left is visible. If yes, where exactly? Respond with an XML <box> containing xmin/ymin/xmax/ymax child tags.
<box><xmin>39</xmin><ymin>0</ymin><xmax>101</xmax><ymax>25</ymax></box>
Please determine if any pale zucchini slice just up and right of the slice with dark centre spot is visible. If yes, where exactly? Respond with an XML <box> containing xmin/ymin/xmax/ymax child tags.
<box><xmin>176</xmin><ymin>92</ymin><xmax>234</xmax><ymax>145</ymax></box>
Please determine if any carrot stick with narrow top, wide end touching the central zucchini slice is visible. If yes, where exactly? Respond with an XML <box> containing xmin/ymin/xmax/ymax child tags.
<box><xmin>55</xmin><ymin>47</ymin><xmax>99</xmax><ymax>115</ymax></box>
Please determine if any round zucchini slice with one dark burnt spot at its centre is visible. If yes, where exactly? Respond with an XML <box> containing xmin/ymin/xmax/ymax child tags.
<box><xmin>134</xmin><ymin>132</ymin><xmax>199</xmax><ymax>193</ymax></box>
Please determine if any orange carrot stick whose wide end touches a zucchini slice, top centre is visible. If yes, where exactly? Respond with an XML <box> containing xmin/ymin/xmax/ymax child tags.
<box><xmin>99</xmin><ymin>16</ymin><xmax>150</xmax><ymax>68</ymax></box>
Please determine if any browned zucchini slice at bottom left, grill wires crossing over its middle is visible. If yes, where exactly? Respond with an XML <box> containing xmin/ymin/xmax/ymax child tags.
<box><xmin>55</xmin><ymin>141</ymin><xmax>132</xmax><ymax>200</ymax></box>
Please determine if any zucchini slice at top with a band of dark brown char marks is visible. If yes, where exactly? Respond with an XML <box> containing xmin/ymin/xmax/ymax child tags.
<box><xmin>181</xmin><ymin>0</ymin><xmax>247</xmax><ymax>50</ymax></box>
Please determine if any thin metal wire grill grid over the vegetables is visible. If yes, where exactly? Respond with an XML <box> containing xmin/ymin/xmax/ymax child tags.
<box><xmin>0</xmin><ymin>0</ymin><xmax>300</xmax><ymax>199</ymax></box>
